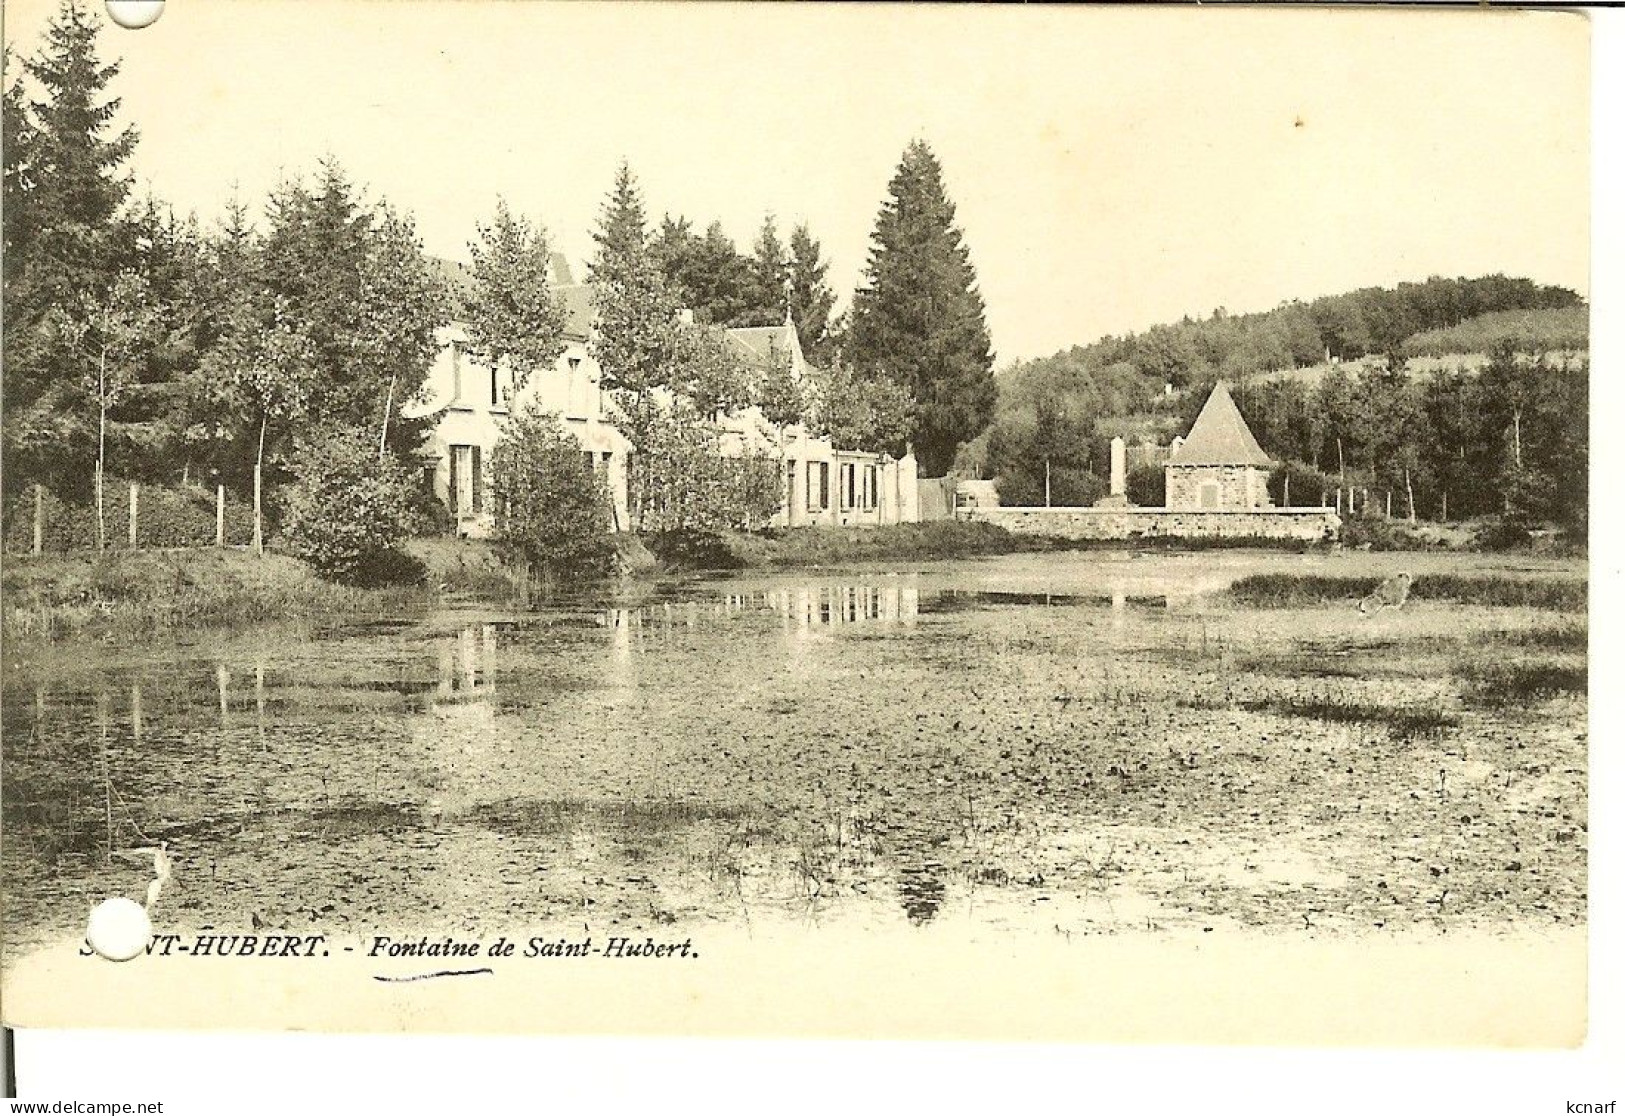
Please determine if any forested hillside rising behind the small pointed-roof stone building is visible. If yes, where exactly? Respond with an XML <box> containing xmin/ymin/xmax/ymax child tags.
<box><xmin>959</xmin><ymin>276</ymin><xmax>1589</xmax><ymax>528</ymax></box>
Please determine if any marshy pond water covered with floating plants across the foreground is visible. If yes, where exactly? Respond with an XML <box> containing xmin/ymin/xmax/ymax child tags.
<box><xmin>3</xmin><ymin>551</ymin><xmax>1586</xmax><ymax>963</ymax></box>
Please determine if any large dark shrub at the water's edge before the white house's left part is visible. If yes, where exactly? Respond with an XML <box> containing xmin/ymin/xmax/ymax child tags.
<box><xmin>491</xmin><ymin>404</ymin><xmax>614</xmax><ymax>582</ymax></box>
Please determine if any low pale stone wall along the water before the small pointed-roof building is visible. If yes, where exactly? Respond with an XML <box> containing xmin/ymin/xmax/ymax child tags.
<box><xmin>960</xmin><ymin>507</ymin><xmax>1342</xmax><ymax>543</ymax></box>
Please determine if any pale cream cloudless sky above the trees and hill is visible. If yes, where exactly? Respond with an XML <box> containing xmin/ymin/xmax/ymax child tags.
<box><xmin>5</xmin><ymin>0</ymin><xmax>1589</xmax><ymax>364</ymax></box>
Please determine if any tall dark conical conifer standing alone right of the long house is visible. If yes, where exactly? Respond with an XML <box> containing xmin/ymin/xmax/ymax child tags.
<box><xmin>845</xmin><ymin>140</ymin><xmax>995</xmax><ymax>476</ymax></box>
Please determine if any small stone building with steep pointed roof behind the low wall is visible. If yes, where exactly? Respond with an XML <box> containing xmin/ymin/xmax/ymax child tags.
<box><xmin>1164</xmin><ymin>380</ymin><xmax>1271</xmax><ymax>512</ymax></box>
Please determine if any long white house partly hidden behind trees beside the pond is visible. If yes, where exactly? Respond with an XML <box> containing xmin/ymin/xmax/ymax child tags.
<box><xmin>405</xmin><ymin>261</ymin><xmax>920</xmax><ymax>538</ymax></box>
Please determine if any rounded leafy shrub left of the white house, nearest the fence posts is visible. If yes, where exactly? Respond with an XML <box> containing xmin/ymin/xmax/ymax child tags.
<box><xmin>281</xmin><ymin>427</ymin><xmax>421</xmax><ymax>585</ymax></box>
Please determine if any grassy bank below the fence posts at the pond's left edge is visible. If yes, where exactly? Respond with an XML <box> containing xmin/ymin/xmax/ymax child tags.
<box><xmin>0</xmin><ymin>549</ymin><xmax>432</xmax><ymax>642</ymax></box>
